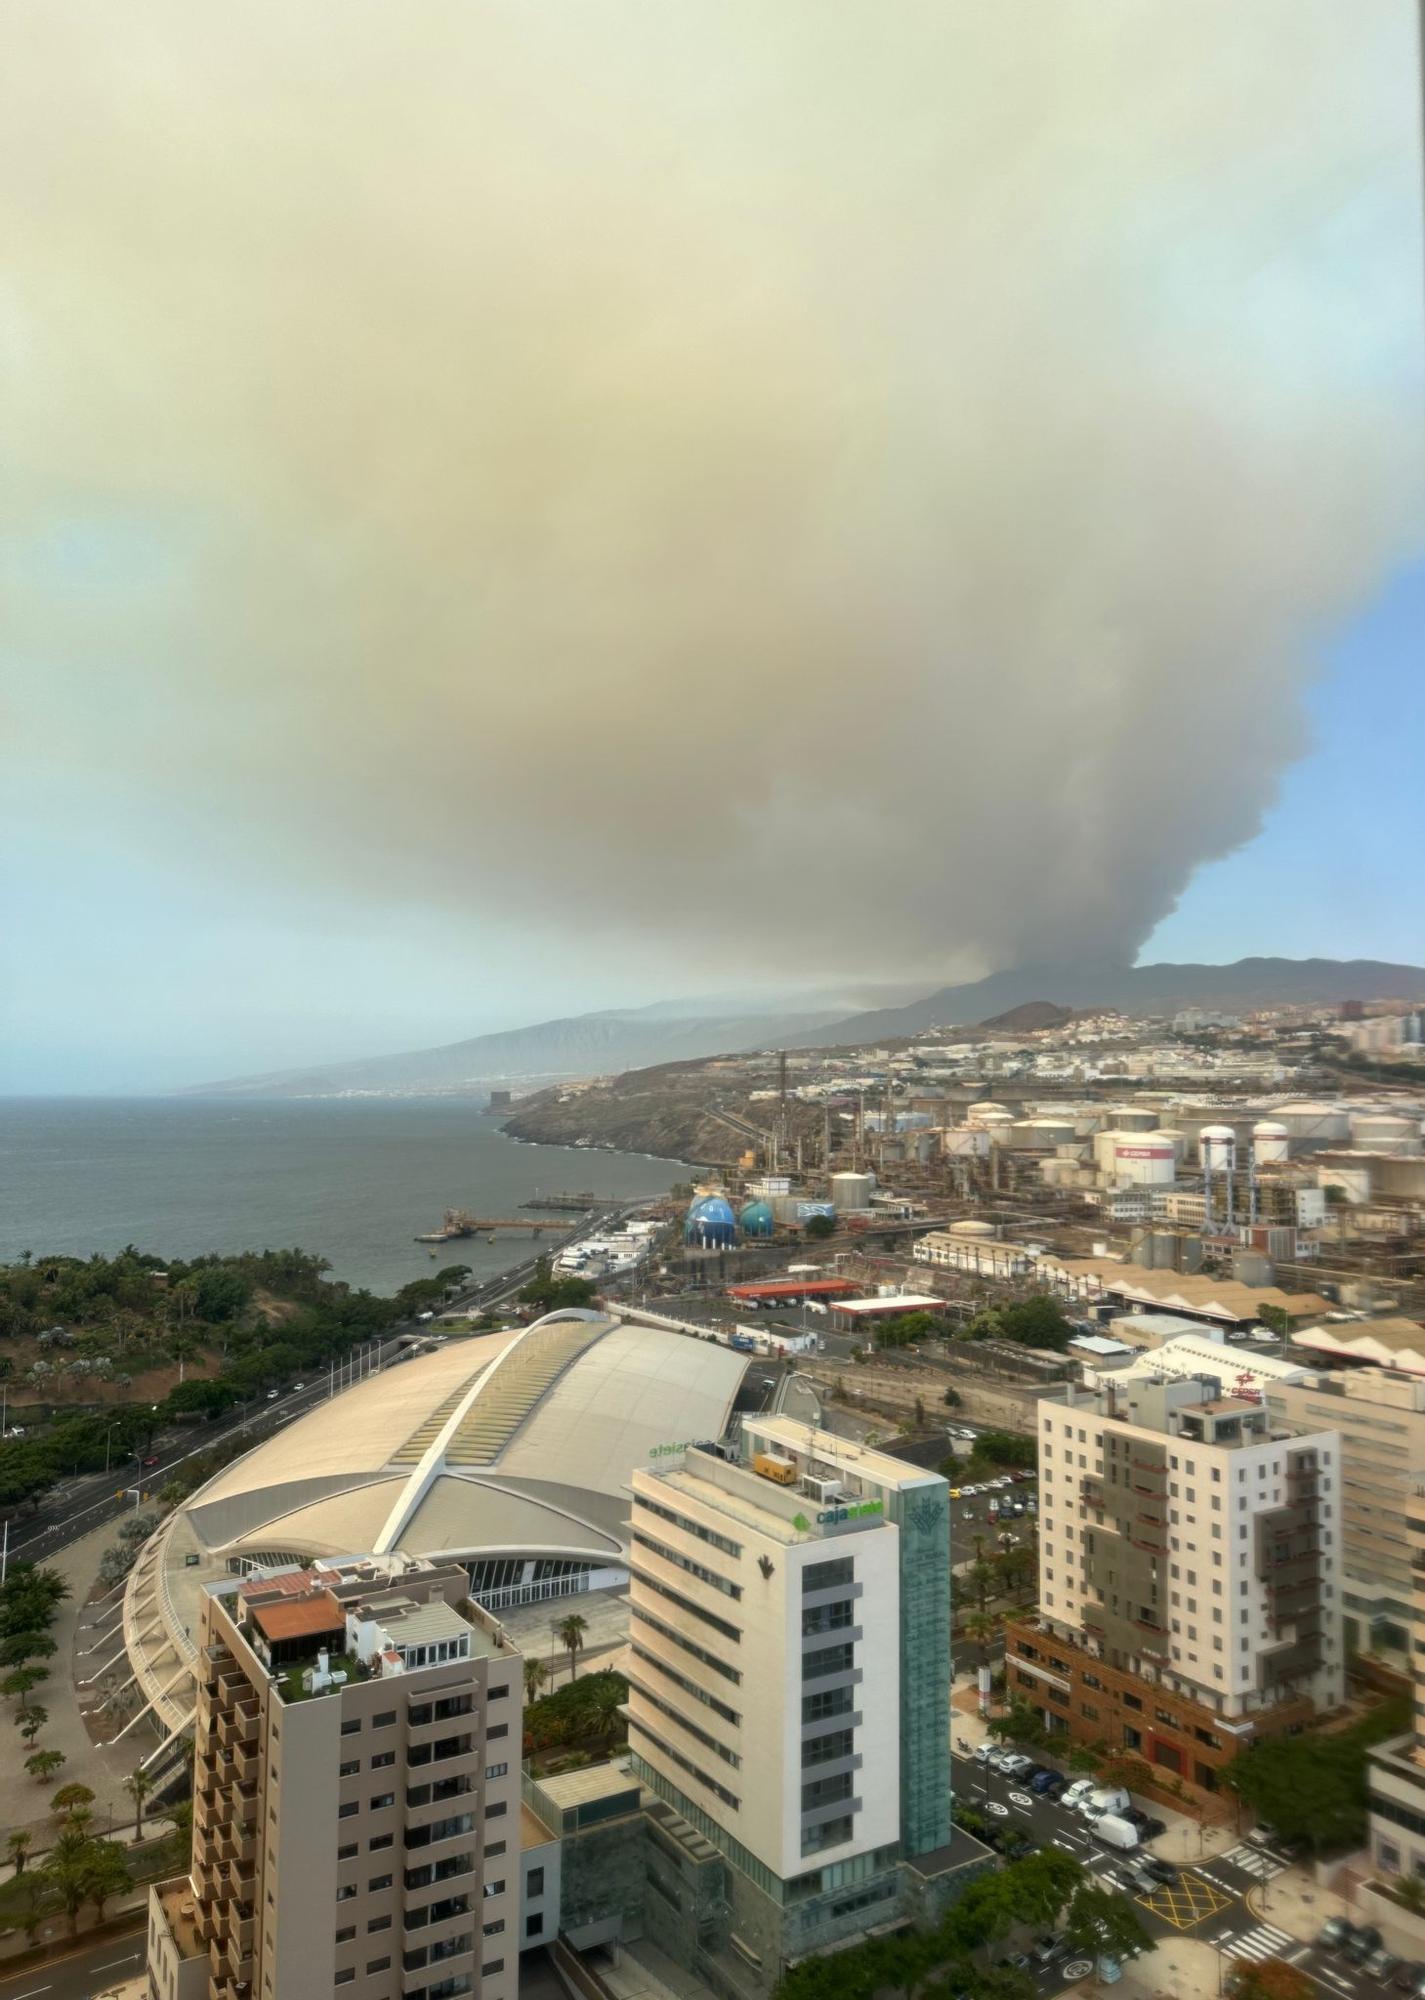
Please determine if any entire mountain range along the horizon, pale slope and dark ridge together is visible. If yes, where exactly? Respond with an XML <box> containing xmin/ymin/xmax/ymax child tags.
<box><xmin>190</xmin><ymin>958</ymin><xmax>1425</xmax><ymax>1098</ymax></box>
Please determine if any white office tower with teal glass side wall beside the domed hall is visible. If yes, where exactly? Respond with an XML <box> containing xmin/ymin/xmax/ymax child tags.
<box><xmin>628</xmin><ymin>1418</ymin><xmax>953</xmax><ymax>1992</ymax></box>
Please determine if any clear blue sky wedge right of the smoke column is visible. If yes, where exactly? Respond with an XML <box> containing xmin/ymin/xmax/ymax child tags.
<box><xmin>1141</xmin><ymin>562</ymin><xmax>1425</xmax><ymax>964</ymax></box>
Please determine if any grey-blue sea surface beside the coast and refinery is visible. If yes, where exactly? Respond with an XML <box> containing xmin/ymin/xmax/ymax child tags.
<box><xmin>0</xmin><ymin>1098</ymin><xmax>686</xmax><ymax>1294</ymax></box>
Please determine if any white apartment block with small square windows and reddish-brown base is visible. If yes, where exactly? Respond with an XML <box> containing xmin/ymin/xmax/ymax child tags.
<box><xmin>1007</xmin><ymin>1372</ymin><xmax>1345</xmax><ymax>1788</ymax></box>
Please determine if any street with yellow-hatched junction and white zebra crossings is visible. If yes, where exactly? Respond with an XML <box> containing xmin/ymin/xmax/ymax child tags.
<box><xmin>951</xmin><ymin>1756</ymin><xmax>1379</xmax><ymax>2000</ymax></box>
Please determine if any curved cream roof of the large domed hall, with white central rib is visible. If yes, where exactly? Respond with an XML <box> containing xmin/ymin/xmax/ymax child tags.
<box><xmin>184</xmin><ymin>1312</ymin><xmax>747</xmax><ymax>1560</ymax></box>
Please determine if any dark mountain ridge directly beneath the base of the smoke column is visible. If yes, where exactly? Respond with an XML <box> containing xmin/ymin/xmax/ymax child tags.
<box><xmin>793</xmin><ymin>958</ymin><xmax>1425</xmax><ymax>1048</ymax></box>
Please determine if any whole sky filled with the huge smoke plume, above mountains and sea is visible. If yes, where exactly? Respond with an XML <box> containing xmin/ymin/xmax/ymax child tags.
<box><xmin>0</xmin><ymin>0</ymin><xmax>1425</xmax><ymax>1090</ymax></box>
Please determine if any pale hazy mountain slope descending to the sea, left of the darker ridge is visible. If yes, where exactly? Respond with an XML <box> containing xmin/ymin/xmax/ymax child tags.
<box><xmin>182</xmin><ymin>1002</ymin><xmax>837</xmax><ymax>1098</ymax></box>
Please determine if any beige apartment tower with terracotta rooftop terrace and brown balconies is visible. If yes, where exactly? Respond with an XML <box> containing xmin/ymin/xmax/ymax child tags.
<box><xmin>148</xmin><ymin>1554</ymin><xmax>522</xmax><ymax>2000</ymax></box>
